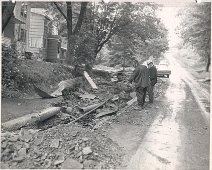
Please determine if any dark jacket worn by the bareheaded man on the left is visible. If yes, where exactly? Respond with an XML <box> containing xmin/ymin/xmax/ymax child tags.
<box><xmin>129</xmin><ymin>65</ymin><xmax>150</xmax><ymax>88</ymax></box>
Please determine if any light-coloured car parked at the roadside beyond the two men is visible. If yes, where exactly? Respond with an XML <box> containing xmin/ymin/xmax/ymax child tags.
<box><xmin>156</xmin><ymin>61</ymin><xmax>171</xmax><ymax>78</ymax></box>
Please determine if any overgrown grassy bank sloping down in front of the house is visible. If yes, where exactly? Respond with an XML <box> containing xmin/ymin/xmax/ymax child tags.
<box><xmin>2</xmin><ymin>59</ymin><xmax>73</xmax><ymax>98</ymax></box>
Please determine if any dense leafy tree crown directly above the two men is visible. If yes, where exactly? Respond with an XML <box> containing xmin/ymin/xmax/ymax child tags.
<box><xmin>107</xmin><ymin>3</ymin><xmax>168</xmax><ymax>65</ymax></box>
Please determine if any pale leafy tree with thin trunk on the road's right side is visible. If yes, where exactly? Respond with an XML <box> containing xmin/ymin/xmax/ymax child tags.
<box><xmin>177</xmin><ymin>3</ymin><xmax>211</xmax><ymax>72</ymax></box>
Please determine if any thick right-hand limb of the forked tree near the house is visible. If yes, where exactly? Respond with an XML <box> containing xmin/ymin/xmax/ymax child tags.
<box><xmin>73</xmin><ymin>2</ymin><xmax>88</xmax><ymax>34</ymax></box>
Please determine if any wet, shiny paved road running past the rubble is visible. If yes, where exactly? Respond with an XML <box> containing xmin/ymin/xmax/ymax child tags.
<box><xmin>128</xmin><ymin>54</ymin><xmax>210</xmax><ymax>170</ymax></box>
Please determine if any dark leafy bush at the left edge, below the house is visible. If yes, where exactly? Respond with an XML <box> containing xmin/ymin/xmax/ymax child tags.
<box><xmin>2</xmin><ymin>45</ymin><xmax>18</xmax><ymax>89</ymax></box>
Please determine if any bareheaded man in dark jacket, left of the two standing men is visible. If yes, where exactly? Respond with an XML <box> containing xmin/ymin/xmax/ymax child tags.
<box><xmin>129</xmin><ymin>61</ymin><xmax>149</xmax><ymax>109</ymax></box>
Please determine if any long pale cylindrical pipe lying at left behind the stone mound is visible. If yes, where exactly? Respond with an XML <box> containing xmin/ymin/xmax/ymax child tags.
<box><xmin>1</xmin><ymin>107</ymin><xmax>60</xmax><ymax>130</ymax></box>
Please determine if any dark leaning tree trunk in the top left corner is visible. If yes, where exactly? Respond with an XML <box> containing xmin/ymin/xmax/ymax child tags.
<box><xmin>2</xmin><ymin>1</ymin><xmax>16</xmax><ymax>33</ymax></box>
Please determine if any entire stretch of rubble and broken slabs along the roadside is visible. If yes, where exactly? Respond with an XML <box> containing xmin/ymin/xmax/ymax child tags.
<box><xmin>1</xmin><ymin>65</ymin><xmax>167</xmax><ymax>169</ymax></box>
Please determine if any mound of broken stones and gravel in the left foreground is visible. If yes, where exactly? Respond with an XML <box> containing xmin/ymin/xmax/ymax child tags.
<box><xmin>1</xmin><ymin>124</ymin><xmax>122</xmax><ymax>169</ymax></box>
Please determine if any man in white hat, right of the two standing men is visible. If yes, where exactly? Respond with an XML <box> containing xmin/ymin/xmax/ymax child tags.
<box><xmin>147</xmin><ymin>60</ymin><xmax>157</xmax><ymax>103</ymax></box>
